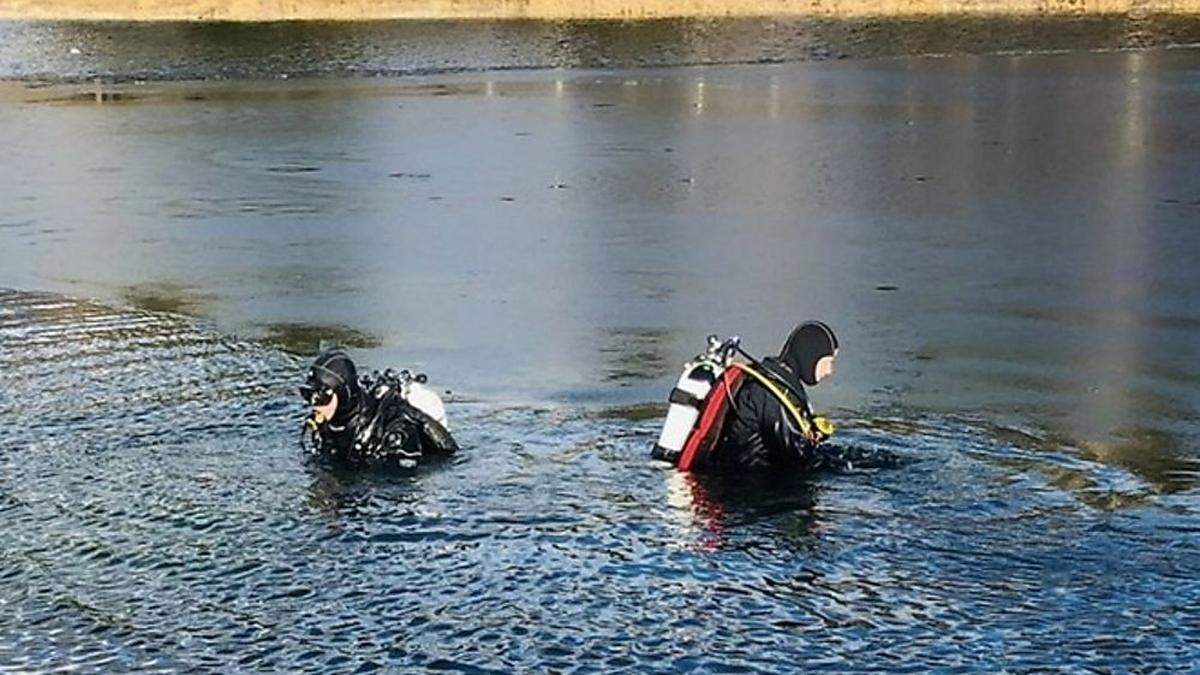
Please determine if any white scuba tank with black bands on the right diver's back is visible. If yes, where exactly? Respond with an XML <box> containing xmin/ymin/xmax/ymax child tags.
<box><xmin>652</xmin><ymin>335</ymin><xmax>740</xmax><ymax>462</ymax></box>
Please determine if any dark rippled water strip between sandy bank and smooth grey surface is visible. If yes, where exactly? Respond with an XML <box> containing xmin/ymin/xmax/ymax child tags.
<box><xmin>0</xmin><ymin>14</ymin><xmax>1200</xmax><ymax>84</ymax></box>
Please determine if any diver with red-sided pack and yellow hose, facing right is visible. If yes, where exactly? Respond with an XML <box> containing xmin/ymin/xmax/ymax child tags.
<box><xmin>653</xmin><ymin>321</ymin><xmax>838</xmax><ymax>474</ymax></box>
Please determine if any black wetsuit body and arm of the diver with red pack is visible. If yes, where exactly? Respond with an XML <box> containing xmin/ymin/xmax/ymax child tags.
<box><xmin>694</xmin><ymin>358</ymin><xmax>814</xmax><ymax>473</ymax></box>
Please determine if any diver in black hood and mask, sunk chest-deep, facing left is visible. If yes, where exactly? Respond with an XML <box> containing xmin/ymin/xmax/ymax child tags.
<box><xmin>300</xmin><ymin>350</ymin><xmax>458</xmax><ymax>468</ymax></box>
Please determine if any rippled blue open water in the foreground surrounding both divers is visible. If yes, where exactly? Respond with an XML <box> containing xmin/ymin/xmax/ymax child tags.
<box><xmin>0</xmin><ymin>291</ymin><xmax>1200</xmax><ymax>671</ymax></box>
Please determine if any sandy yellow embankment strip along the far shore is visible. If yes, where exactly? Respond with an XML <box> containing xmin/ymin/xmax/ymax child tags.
<box><xmin>0</xmin><ymin>0</ymin><xmax>1200</xmax><ymax>22</ymax></box>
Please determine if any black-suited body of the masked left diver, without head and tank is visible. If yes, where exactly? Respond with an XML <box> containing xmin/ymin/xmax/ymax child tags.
<box><xmin>310</xmin><ymin>388</ymin><xmax>458</xmax><ymax>468</ymax></box>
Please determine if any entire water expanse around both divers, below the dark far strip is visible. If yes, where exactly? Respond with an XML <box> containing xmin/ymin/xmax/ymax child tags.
<box><xmin>0</xmin><ymin>30</ymin><xmax>1200</xmax><ymax>671</ymax></box>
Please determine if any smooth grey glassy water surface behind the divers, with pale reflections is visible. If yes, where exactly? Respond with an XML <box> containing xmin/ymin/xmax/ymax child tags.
<box><xmin>0</xmin><ymin>50</ymin><xmax>1200</xmax><ymax>489</ymax></box>
